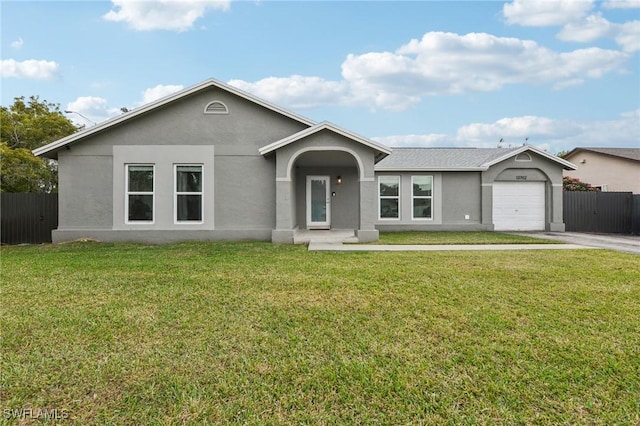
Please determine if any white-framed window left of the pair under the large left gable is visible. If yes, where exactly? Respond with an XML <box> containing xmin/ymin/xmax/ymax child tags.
<box><xmin>125</xmin><ymin>164</ymin><xmax>155</xmax><ymax>223</ymax></box>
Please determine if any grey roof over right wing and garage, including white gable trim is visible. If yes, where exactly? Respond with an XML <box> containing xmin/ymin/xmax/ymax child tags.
<box><xmin>375</xmin><ymin>145</ymin><xmax>576</xmax><ymax>171</ymax></box>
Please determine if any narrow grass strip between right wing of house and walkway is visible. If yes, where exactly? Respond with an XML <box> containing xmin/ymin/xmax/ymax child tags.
<box><xmin>371</xmin><ymin>231</ymin><xmax>562</xmax><ymax>244</ymax></box>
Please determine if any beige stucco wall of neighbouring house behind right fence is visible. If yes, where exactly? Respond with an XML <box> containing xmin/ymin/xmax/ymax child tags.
<box><xmin>564</xmin><ymin>151</ymin><xmax>640</xmax><ymax>194</ymax></box>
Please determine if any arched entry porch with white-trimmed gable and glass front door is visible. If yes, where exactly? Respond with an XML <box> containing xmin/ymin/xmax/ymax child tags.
<box><xmin>260</xmin><ymin>123</ymin><xmax>391</xmax><ymax>243</ymax></box>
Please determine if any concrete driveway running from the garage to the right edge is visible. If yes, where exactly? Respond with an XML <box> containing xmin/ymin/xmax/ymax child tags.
<box><xmin>521</xmin><ymin>232</ymin><xmax>640</xmax><ymax>254</ymax></box>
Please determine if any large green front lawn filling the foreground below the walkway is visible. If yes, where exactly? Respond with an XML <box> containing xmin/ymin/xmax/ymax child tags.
<box><xmin>0</xmin><ymin>243</ymin><xmax>640</xmax><ymax>425</ymax></box>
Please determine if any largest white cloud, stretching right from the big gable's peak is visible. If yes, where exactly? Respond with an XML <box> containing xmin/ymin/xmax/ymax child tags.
<box><xmin>230</xmin><ymin>32</ymin><xmax>629</xmax><ymax>110</ymax></box>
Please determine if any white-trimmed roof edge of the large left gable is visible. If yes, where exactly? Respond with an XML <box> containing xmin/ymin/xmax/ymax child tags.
<box><xmin>33</xmin><ymin>78</ymin><xmax>316</xmax><ymax>158</ymax></box>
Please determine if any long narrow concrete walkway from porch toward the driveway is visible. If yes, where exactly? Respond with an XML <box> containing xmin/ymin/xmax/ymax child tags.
<box><xmin>309</xmin><ymin>241</ymin><xmax>597</xmax><ymax>251</ymax></box>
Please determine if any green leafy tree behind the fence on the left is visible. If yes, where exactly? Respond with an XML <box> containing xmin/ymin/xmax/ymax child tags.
<box><xmin>0</xmin><ymin>96</ymin><xmax>81</xmax><ymax>192</ymax></box>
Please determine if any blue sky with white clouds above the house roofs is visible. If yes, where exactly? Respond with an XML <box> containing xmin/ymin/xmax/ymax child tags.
<box><xmin>0</xmin><ymin>0</ymin><xmax>640</xmax><ymax>153</ymax></box>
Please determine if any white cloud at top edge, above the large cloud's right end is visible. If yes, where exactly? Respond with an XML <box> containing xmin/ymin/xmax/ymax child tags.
<box><xmin>502</xmin><ymin>0</ymin><xmax>594</xmax><ymax>27</ymax></box>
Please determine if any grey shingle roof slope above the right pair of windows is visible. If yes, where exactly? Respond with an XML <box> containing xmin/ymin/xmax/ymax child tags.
<box><xmin>376</xmin><ymin>148</ymin><xmax>519</xmax><ymax>170</ymax></box>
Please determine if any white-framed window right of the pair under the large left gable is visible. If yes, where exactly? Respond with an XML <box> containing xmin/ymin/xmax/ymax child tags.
<box><xmin>175</xmin><ymin>165</ymin><xmax>203</xmax><ymax>223</ymax></box>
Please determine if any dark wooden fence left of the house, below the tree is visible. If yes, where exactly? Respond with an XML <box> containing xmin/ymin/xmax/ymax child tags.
<box><xmin>0</xmin><ymin>193</ymin><xmax>58</xmax><ymax>244</ymax></box>
